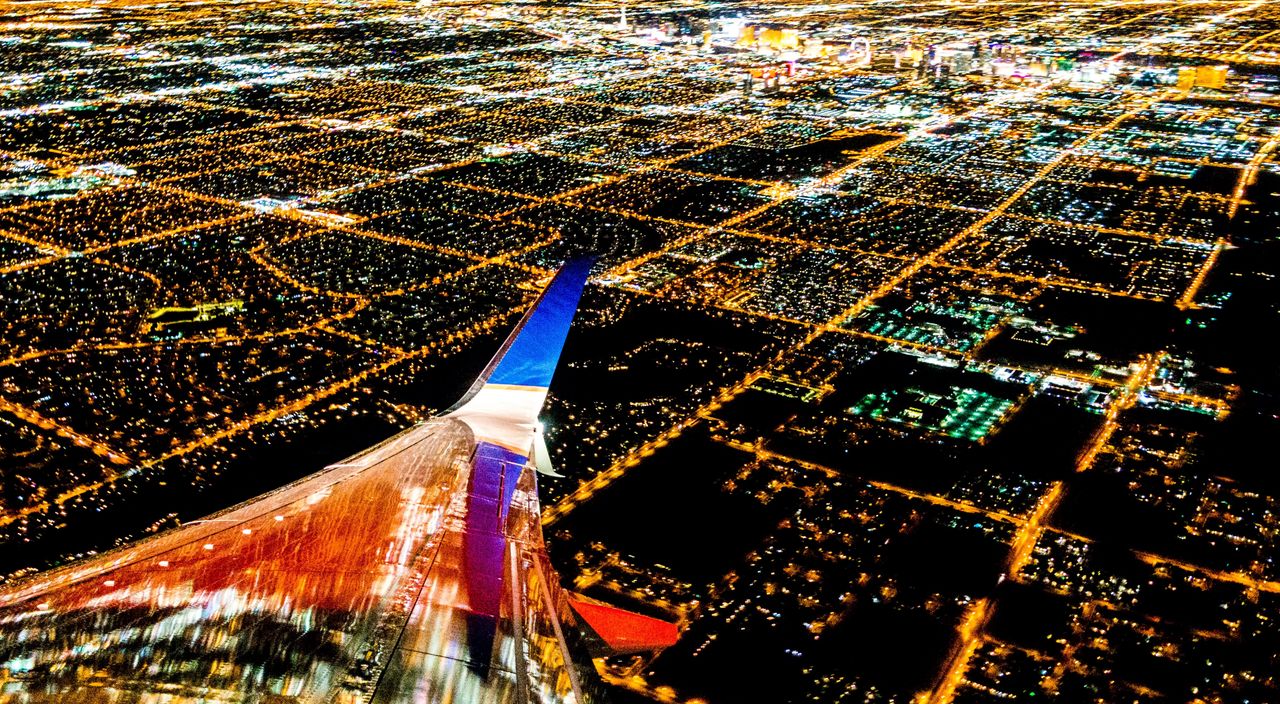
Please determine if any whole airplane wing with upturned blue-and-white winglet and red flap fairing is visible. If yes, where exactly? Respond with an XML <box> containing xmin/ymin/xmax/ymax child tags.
<box><xmin>0</xmin><ymin>259</ymin><xmax>678</xmax><ymax>704</ymax></box>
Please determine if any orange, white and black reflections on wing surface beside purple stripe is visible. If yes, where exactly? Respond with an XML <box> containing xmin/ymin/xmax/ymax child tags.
<box><xmin>0</xmin><ymin>419</ymin><xmax>591</xmax><ymax>704</ymax></box>
